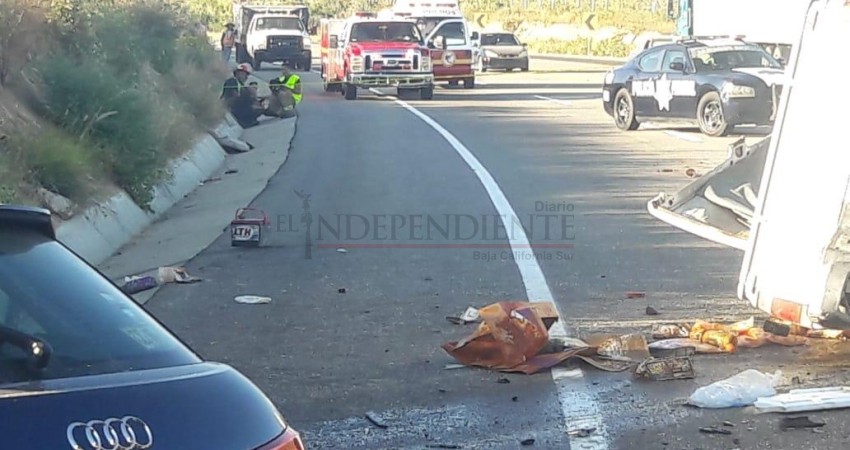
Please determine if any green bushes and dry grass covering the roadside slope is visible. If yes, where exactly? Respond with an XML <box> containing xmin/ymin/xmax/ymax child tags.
<box><xmin>0</xmin><ymin>0</ymin><xmax>227</xmax><ymax>207</ymax></box>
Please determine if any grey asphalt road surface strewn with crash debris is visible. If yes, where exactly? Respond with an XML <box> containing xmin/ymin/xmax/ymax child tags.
<box><xmin>142</xmin><ymin>62</ymin><xmax>848</xmax><ymax>449</ymax></box>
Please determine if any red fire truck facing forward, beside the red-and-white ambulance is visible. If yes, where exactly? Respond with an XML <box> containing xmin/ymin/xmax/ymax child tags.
<box><xmin>320</xmin><ymin>13</ymin><xmax>434</xmax><ymax>100</ymax></box>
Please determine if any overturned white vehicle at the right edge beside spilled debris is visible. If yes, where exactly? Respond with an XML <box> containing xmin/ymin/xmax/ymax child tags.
<box><xmin>648</xmin><ymin>0</ymin><xmax>850</xmax><ymax>330</ymax></box>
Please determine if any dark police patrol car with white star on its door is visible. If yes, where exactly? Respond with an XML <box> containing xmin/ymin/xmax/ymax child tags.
<box><xmin>602</xmin><ymin>37</ymin><xmax>785</xmax><ymax>136</ymax></box>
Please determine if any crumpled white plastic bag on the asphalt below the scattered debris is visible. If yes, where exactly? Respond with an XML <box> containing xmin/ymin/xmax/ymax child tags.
<box><xmin>688</xmin><ymin>369</ymin><xmax>782</xmax><ymax>408</ymax></box>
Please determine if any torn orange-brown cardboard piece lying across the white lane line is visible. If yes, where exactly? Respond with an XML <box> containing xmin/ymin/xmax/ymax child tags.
<box><xmin>442</xmin><ymin>301</ymin><xmax>632</xmax><ymax>375</ymax></box>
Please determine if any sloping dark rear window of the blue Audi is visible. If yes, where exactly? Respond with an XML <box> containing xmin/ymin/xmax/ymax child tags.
<box><xmin>0</xmin><ymin>227</ymin><xmax>199</xmax><ymax>385</ymax></box>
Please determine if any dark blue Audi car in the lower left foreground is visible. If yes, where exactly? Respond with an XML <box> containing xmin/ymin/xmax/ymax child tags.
<box><xmin>0</xmin><ymin>205</ymin><xmax>304</xmax><ymax>450</ymax></box>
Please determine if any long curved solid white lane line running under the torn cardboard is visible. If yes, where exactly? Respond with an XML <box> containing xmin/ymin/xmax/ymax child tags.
<box><xmin>387</xmin><ymin>96</ymin><xmax>608</xmax><ymax>450</ymax></box>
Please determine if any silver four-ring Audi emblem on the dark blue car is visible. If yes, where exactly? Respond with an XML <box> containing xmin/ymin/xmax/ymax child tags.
<box><xmin>67</xmin><ymin>416</ymin><xmax>153</xmax><ymax>450</ymax></box>
